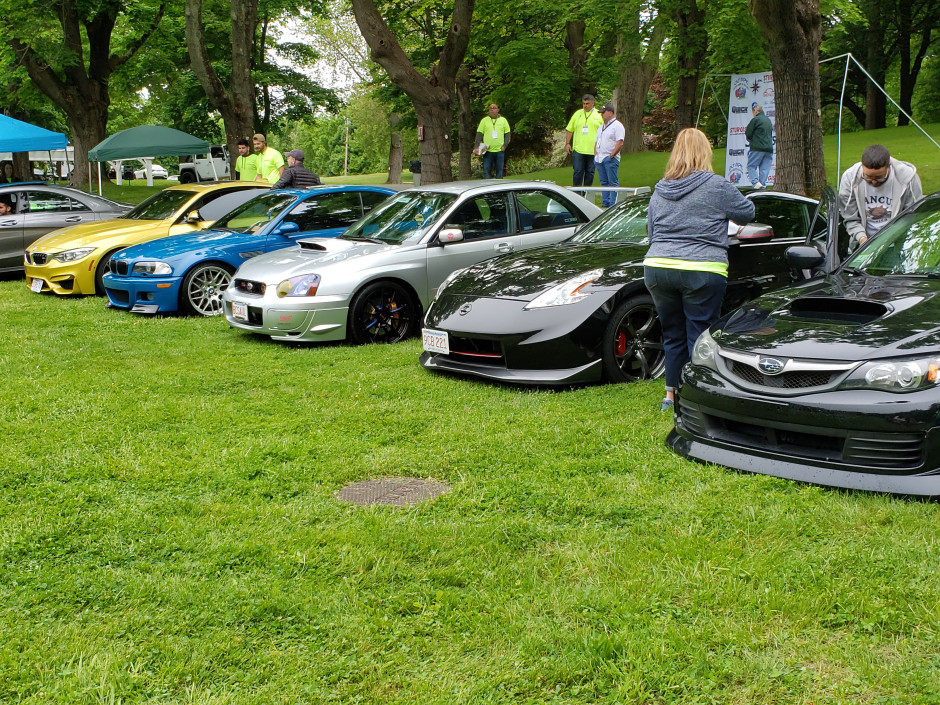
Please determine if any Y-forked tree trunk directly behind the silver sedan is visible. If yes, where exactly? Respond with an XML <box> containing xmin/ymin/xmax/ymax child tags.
<box><xmin>352</xmin><ymin>0</ymin><xmax>475</xmax><ymax>184</ymax></box>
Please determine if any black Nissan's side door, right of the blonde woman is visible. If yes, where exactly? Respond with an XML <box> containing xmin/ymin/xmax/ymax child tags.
<box><xmin>725</xmin><ymin>192</ymin><xmax>815</xmax><ymax>310</ymax></box>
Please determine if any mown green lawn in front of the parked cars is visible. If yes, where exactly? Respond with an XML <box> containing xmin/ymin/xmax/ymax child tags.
<box><xmin>0</xmin><ymin>280</ymin><xmax>940</xmax><ymax>705</ymax></box>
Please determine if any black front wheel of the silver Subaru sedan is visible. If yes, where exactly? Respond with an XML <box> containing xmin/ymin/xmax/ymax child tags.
<box><xmin>349</xmin><ymin>281</ymin><xmax>421</xmax><ymax>344</ymax></box>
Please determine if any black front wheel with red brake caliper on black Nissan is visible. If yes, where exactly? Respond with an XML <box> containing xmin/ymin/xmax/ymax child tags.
<box><xmin>603</xmin><ymin>294</ymin><xmax>666</xmax><ymax>383</ymax></box>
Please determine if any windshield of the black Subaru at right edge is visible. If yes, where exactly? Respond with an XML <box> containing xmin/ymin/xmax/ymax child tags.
<box><xmin>845</xmin><ymin>198</ymin><xmax>940</xmax><ymax>276</ymax></box>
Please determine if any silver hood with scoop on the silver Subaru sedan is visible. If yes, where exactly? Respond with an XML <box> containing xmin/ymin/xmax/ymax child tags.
<box><xmin>238</xmin><ymin>237</ymin><xmax>402</xmax><ymax>283</ymax></box>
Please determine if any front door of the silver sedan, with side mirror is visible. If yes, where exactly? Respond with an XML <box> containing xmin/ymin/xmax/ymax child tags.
<box><xmin>425</xmin><ymin>191</ymin><xmax>522</xmax><ymax>300</ymax></box>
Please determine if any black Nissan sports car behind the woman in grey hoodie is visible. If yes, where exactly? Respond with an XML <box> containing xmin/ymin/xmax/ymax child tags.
<box><xmin>421</xmin><ymin>191</ymin><xmax>847</xmax><ymax>385</ymax></box>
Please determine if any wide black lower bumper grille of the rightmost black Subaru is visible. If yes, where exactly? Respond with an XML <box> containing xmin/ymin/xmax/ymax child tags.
<box><xmin>679</xmin><ymin>400</ymin><xmax>926</xmax><ymax>471</ymax></box>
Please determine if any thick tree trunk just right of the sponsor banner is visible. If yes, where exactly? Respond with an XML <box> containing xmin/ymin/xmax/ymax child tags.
<box><xmin>748</xmin><ymin>0</ymin><xmax>826</xmax><ymax>195</ymax></box>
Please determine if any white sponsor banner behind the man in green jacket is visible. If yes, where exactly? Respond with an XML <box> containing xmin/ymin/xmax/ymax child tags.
<box><xmin>725</xmin><ymin>72</ymin><xmax>777</xmax><ymax>186</ymax></box>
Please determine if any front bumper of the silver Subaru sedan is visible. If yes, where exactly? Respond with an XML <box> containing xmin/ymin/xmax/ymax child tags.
<box><xmin>222</xmin><ymin>289</ymin><xmax>349</xmax><ymax>342</ymax></box>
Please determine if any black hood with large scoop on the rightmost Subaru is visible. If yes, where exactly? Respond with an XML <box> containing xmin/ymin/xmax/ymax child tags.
<box><xmin>712</xmin><ymin>273</ymin><xmax>940</xmax><ymax>361</ymax></box>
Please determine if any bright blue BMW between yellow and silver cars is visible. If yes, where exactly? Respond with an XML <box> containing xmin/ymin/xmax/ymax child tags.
<box><xmin>103</xmin><ymin>186</ymin><xmax>395</xmax><ymax>316</ymax></box>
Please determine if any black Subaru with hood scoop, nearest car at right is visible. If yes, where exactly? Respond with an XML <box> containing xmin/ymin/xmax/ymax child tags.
<box><xmin>667</xmin><ymin>193</ymin><xmax>940</xmax><ymax>497</ymax></box>
